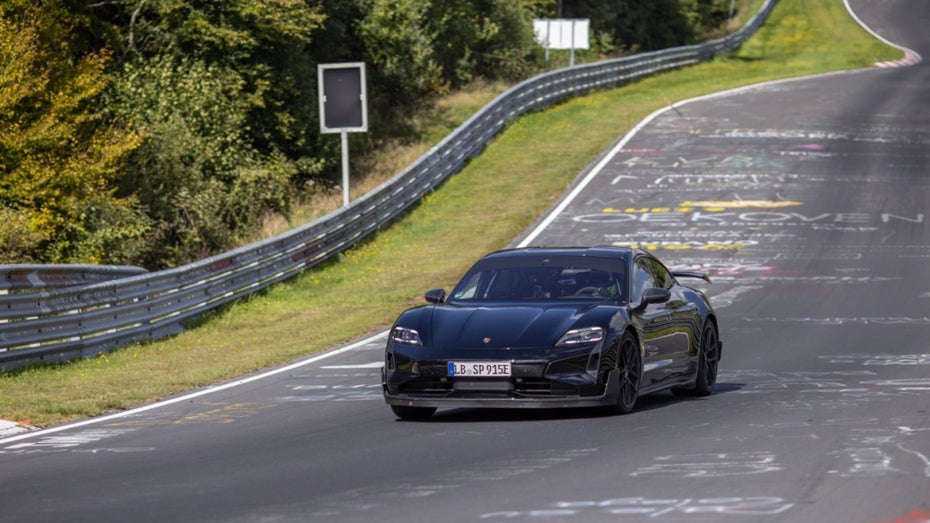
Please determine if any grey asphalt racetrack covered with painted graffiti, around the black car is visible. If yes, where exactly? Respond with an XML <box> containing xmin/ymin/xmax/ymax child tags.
<box><xmin>0</xmin><ymin>0</ymin><xmax>930</xmax><ymax>523</ymax></box>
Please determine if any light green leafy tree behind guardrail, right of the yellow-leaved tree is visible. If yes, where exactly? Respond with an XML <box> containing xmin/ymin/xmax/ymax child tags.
<box><xmin>109</xmin><ymin>56</ymin><xmax>295</xmax><ymax>267</ymax></box>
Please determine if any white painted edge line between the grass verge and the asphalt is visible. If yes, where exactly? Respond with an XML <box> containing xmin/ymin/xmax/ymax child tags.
<box><xmin>0</xmin><ymin>0</ymin><xmax>908</xmax><ymax>446</ymax></box>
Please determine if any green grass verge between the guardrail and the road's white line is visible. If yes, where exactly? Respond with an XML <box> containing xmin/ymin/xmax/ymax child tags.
<box><xmin>0</xmin><ymin>0</ymin><xmax>901</xmax><ymax>426</ymax></box>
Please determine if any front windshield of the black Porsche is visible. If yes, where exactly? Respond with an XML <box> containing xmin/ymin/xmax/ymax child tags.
<box><xmin>450</xmin><ymin>260</ymin><xmax>627</xmax><ymax>302</ymax></box>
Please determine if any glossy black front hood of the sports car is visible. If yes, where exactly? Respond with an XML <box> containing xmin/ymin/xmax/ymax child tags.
<box><xmin>422</xmin><ymin>305</ymin><xmax>593</xmax><ymax>350</ymax></box>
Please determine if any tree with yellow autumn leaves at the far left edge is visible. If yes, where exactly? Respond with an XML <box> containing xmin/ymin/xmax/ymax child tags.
<box><xmin>0</xmin><ymin>1</ymin><xmax>148</xmax><ymax>263</ymax></box>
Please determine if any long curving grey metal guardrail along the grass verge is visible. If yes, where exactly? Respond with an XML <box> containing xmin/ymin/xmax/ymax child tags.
<box><xmin>0</xmin><ymin>0</ymin><xmax>776</xmax><ymax>372</ymax></box>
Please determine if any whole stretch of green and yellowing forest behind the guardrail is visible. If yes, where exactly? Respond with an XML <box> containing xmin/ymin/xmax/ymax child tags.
<box><xmin>0</xmin><ymin>0</ymin><xmax>730</xmax><ymax>270</ymax></box>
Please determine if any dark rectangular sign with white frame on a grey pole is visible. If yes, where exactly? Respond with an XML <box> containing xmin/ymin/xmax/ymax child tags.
<box><xmin>317</xmin><ymin>62</ymin><xmax>368</xmax><ymax>206</ymax></box>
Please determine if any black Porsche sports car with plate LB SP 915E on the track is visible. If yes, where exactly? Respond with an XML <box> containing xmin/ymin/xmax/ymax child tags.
<box><xmin>382</xmin><ymin>247</ymin><xmax>722</xmax><ymax>419</ymax></box>
